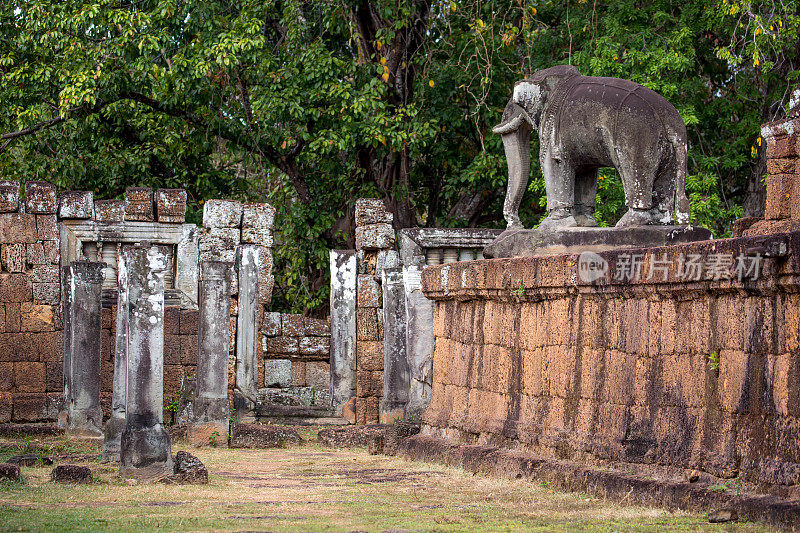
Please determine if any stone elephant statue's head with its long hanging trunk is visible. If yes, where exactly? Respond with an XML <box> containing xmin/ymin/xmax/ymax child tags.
<box><xmin>492</xmin><ymin>65</ymin><xmax>580</xmax><ymax>229</ymax></box>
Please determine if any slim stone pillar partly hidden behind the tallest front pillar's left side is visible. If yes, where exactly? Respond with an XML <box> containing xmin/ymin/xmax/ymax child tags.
<box><xmin>103</xmin><ymin>246</ymin><xmax>131</xmax><ymax>462</ymax></box>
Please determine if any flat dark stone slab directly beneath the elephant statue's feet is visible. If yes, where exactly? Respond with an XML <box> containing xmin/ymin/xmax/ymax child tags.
<box><xmin>483</xmin><ymin>226</ymin><xmax>712</xmax><ymax>259</ymax></box>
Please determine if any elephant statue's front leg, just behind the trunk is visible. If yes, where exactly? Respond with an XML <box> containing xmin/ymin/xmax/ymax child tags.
<box><xmin>539</xmin><ymin>146</ymin><xmax>578</xmax><ymax>230</ymax></box>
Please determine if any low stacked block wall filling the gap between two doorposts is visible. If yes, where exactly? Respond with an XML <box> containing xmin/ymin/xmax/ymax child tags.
<box><xmin>259</xmin><ymin>312</ymin><xmax>331</xmax><ymax>396</ymax></box>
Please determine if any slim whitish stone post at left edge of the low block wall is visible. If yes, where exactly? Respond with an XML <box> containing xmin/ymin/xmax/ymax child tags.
<box><xmin>234</xmin><ymin>245</ymin><xmax>260</xmax><ymax>412</ymax></box>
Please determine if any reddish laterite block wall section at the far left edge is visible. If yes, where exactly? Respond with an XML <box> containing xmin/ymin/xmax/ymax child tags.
<box><xmin>0</xmin><ymin>181</ymin><xmax>64</xmax><ymax>423</ymax></box>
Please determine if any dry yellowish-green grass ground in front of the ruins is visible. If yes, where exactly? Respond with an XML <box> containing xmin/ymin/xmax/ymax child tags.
<box><xmin>0</xmin><ymin>432</ymin><xmax>767</xmax><ymax>533</ymax></box>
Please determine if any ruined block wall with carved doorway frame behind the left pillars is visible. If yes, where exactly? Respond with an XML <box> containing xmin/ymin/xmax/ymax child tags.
<box><xmin>0</xmin><ymin>181</ymin><xmax>274</xmax><ymax>423</ymax></box>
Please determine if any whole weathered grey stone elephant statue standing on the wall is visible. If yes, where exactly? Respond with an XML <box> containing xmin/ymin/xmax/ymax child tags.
<box><xmin>493</xmin><ymin>65</ymin><xmax>689</xmax><ymax>229</ymax></box>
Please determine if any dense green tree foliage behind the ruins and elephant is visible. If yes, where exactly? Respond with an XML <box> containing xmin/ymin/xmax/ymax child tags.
<box><xmin>0</xmin><ymin>0</ymin><xmax>800</xmax><ymax>311</ymax></box>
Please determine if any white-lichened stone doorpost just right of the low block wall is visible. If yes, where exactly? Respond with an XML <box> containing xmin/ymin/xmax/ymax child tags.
<box><xmin>331</xmin><ymin>250</ymin><xmax>358</xmax><ymax>423</ymax></box>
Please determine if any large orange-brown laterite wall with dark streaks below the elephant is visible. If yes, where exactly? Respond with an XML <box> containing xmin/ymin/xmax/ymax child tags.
<box><xmin>422</xmin><ymin>233</ymin><xmax>800</xmax><ymax>485</ymax></box>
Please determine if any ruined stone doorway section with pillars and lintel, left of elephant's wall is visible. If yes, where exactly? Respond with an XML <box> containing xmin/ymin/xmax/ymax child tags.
<box><xmin>330</xmin><ymin>204</ymin><xmax>501</xmax><ymax>424</ymax></box>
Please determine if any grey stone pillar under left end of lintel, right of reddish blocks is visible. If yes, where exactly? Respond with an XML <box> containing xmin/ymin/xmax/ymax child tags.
<box><xmin>380</xmin><ymin>268</ymin><xmax>409</xmax><ymax>424</ymax></box>
